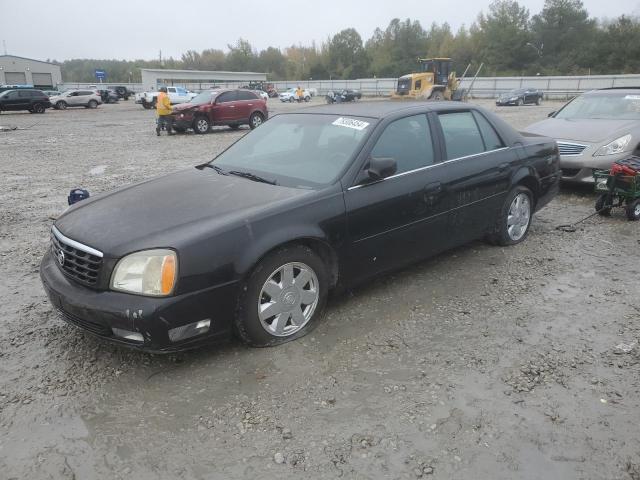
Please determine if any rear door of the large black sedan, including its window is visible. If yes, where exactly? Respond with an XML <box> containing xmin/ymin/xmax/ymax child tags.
<box><xmin>435</xmin><ymin>109</ymin><xmax>518</xmax><ymax>245</ymax></box>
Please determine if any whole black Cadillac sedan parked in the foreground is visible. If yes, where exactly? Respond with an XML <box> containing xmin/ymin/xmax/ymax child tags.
<box><xmin>40</xmin><ymin>102</ymin><xmax>560</xmax><ymax>352</ymax></box>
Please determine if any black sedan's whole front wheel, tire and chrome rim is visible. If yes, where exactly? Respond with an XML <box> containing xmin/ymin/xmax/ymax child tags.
<box><xmin>235</xmin><ymin>245</ymin><xmax>328</xmax><ymax>347</ymax></box>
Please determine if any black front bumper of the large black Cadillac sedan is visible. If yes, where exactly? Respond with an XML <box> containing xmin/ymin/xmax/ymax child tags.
<box><xmin>40</xmin><ymin>250</ymin><xmax>237</xmax><ymax>353</ymax></box>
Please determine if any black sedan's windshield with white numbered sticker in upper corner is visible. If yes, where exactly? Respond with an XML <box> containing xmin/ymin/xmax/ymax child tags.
<box><xmin>213</xmin><ymin>114</ymin><xmax>375</xmax><ymax>188</ymax></box>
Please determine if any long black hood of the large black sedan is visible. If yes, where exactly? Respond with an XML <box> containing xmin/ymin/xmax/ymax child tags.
<box><xmin>55</xmin><ymin>168</ymin><xmax>312</xmax><ymax>257</ymax></box>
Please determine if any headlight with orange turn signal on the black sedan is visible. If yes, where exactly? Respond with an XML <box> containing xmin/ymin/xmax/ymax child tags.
<box><xmin>111</xmin><ymin>249</ymin><xmax>178</xmax><ymax>297</ymax></box>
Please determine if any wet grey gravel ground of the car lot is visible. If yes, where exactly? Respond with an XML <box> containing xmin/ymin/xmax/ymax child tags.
<box><xmin>0</xmin><ymin>100</ymin><xmax>640</xmax><ymax>480</ymax></box>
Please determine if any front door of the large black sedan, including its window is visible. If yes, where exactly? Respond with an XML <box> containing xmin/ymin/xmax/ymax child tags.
<box><xmin>345</xmin><ymin>114</ymin><xmax>446</xmax><ymax>281</ymax></box>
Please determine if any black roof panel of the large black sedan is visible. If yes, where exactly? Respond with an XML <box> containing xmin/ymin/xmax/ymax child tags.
<box><xmin>292</xmin><ymin>100</ymin><xmax>476</xmax><ymax>118</ymax></box>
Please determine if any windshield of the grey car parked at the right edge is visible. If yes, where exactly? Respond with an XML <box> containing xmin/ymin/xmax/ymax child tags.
<box><xmin>556</xmin><ymin>92</ymin><xmax>640</xmax><ymax>120</ymax></box>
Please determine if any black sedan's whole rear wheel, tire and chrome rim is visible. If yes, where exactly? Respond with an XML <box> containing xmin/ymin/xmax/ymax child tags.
<box><xmin>489</xmin><ymin>185</ymin><xmax>534</xmax><ymax>245</ymax></box>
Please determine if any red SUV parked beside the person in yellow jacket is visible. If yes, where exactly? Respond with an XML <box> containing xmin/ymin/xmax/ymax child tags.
<box><xmin>172</xmin><ymin>89</ymin><xmax>269</xmax><ymax>133</ymax></box>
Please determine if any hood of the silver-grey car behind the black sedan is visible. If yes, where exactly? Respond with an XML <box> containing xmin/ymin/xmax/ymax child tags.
<box><xmin>525</xmin><ymin>118</ymin><xmax>640</xmax><ymax>143</ymax></box>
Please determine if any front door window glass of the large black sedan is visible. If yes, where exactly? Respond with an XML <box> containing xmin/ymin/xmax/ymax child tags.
<box><xmin>371</xmin><ymin>115</ymin><xmax>434</xmax><ymax>173</ymax></box>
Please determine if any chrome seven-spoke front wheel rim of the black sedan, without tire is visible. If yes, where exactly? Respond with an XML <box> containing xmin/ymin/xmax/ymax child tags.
<box><xmin>258</xmin><ymin>262</ymin><xmax>320</xmax><ymax>337</ymax></box>
